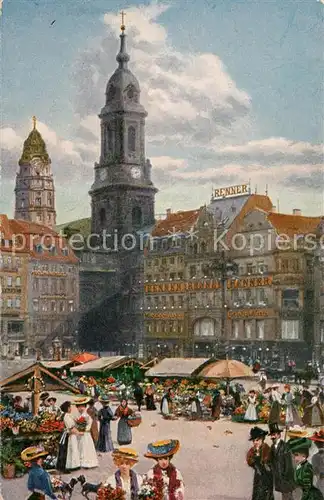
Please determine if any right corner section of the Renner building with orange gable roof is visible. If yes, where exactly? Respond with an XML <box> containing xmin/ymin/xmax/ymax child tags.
<box><xmin>225</xmin><ymin>209</ymin><xmax>321</xmax><ymax>367</ymax></box>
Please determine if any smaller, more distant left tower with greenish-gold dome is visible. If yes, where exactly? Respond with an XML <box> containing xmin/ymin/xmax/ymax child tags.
<box><xmin>15</xmin><ymin>116</ymin><xmax>56</xmax><ymax>228</ymax></box>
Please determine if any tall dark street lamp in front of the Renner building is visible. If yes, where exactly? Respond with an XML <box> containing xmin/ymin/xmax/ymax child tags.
<box><xmin>210</xmin><ymin>251</ymin><xmax>238</xmax><ymax>359</ymax></box>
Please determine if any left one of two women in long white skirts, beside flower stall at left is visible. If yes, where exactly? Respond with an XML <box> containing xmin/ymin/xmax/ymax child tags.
<box><xmin>59</xmin><ymin>401</ymin><xmax>81</xmax><ymax>471</ymax></box>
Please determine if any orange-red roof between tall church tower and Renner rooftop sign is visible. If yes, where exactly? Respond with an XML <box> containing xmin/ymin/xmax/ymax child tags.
<box><xmin>152</xmin><ymin>208</ymin><xmax>202</xmax><ymax>237</ymax></box>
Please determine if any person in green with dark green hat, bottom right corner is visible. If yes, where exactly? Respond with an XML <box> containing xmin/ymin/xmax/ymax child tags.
<box><xmin>288</xmin><ymin>438</ymin><xmax>324</xmax><ymax>500</ymax></box>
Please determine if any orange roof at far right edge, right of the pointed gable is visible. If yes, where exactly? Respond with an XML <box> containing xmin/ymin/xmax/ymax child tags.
<box><xmin>267</xmin><ymin>213</ymin><xmax>322</xmax><ymax>237</ymax></box>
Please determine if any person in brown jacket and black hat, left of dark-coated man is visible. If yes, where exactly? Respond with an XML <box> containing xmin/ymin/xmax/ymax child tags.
<box><xmin>246</xmin><ymin>427</ymin><xmax>274</xmax><ymax>500</ymax></box>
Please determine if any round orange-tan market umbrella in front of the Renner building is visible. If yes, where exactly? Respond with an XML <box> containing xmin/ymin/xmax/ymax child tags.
<box><xmin>198</xmin><ymin>359</ymin><xmax>255</xmax><ymax>379</ymax></box>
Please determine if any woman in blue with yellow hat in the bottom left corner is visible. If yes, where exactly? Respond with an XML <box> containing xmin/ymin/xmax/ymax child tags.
<box><xmin>21</xmin><ymin>446</ymin><xmax>57</xmax><ymax>500</ymax></box>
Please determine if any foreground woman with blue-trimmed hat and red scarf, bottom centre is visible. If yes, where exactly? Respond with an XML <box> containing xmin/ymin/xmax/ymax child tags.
<box><xmin>144</xmin><ymin>439</ymin><xmax>184</xmax><ymax>500</ymax></box>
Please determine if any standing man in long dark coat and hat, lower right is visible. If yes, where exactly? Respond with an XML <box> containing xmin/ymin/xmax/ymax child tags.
<box><xmin>269</xmin><ymin>424</ymin><xmax>296</xmax><ymax>500</ymax></box>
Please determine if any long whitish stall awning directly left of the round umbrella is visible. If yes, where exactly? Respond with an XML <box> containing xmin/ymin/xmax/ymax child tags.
<box><xmin>145</xmin><ymin>358</ymin><xmax>210</xmax><ymax>377</ymax></box>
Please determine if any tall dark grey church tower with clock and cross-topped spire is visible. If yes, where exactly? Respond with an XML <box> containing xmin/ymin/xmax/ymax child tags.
<box><xmin>89</xmin><ymin>18</ymin><xmax>157</xmax><ymax>237</ymax></box>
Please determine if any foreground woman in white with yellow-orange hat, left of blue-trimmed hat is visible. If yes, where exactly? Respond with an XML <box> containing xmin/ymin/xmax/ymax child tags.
<box><xmin>104</xmin><ymin>448</ymin><xmax>143</xmax><ymax>500</ymax></box>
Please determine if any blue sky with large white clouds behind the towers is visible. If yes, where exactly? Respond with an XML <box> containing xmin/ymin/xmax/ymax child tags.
<box><xmin>0</xmin><ymin>0</ymin><xmax>324</xmax><ymax>223</ymax></box>
